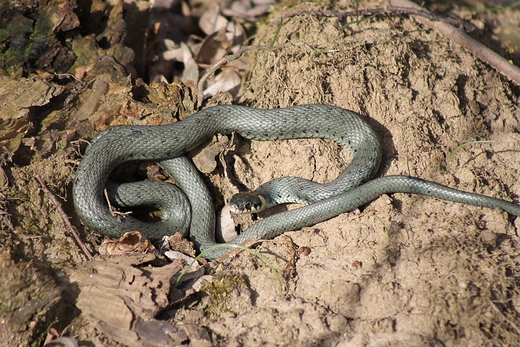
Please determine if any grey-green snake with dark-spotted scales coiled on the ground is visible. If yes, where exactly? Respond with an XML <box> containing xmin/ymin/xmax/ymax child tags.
<box><xmin>72</xmin><ymin>104</ymin><xmax>520</xmax><ymax>260</ymax></box>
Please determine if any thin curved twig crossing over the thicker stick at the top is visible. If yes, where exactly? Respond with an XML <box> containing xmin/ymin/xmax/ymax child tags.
<box><xmin>272</xmin><ymin>6</ymin><xmax>475</xmax><ymax>31</ymax></box>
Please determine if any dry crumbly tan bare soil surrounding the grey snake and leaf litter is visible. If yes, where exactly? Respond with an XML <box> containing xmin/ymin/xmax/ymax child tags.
<box><xmin>0</xmin><ymin>0</ymin><xmax>520</xmax><ymax>346</ymax></box>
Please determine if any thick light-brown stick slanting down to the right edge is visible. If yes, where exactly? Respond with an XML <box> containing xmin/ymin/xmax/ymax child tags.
<box><xmin>391</xmin><ymin>0</ymin><xmax>520</xmax><ymax>85</ymax></box>
